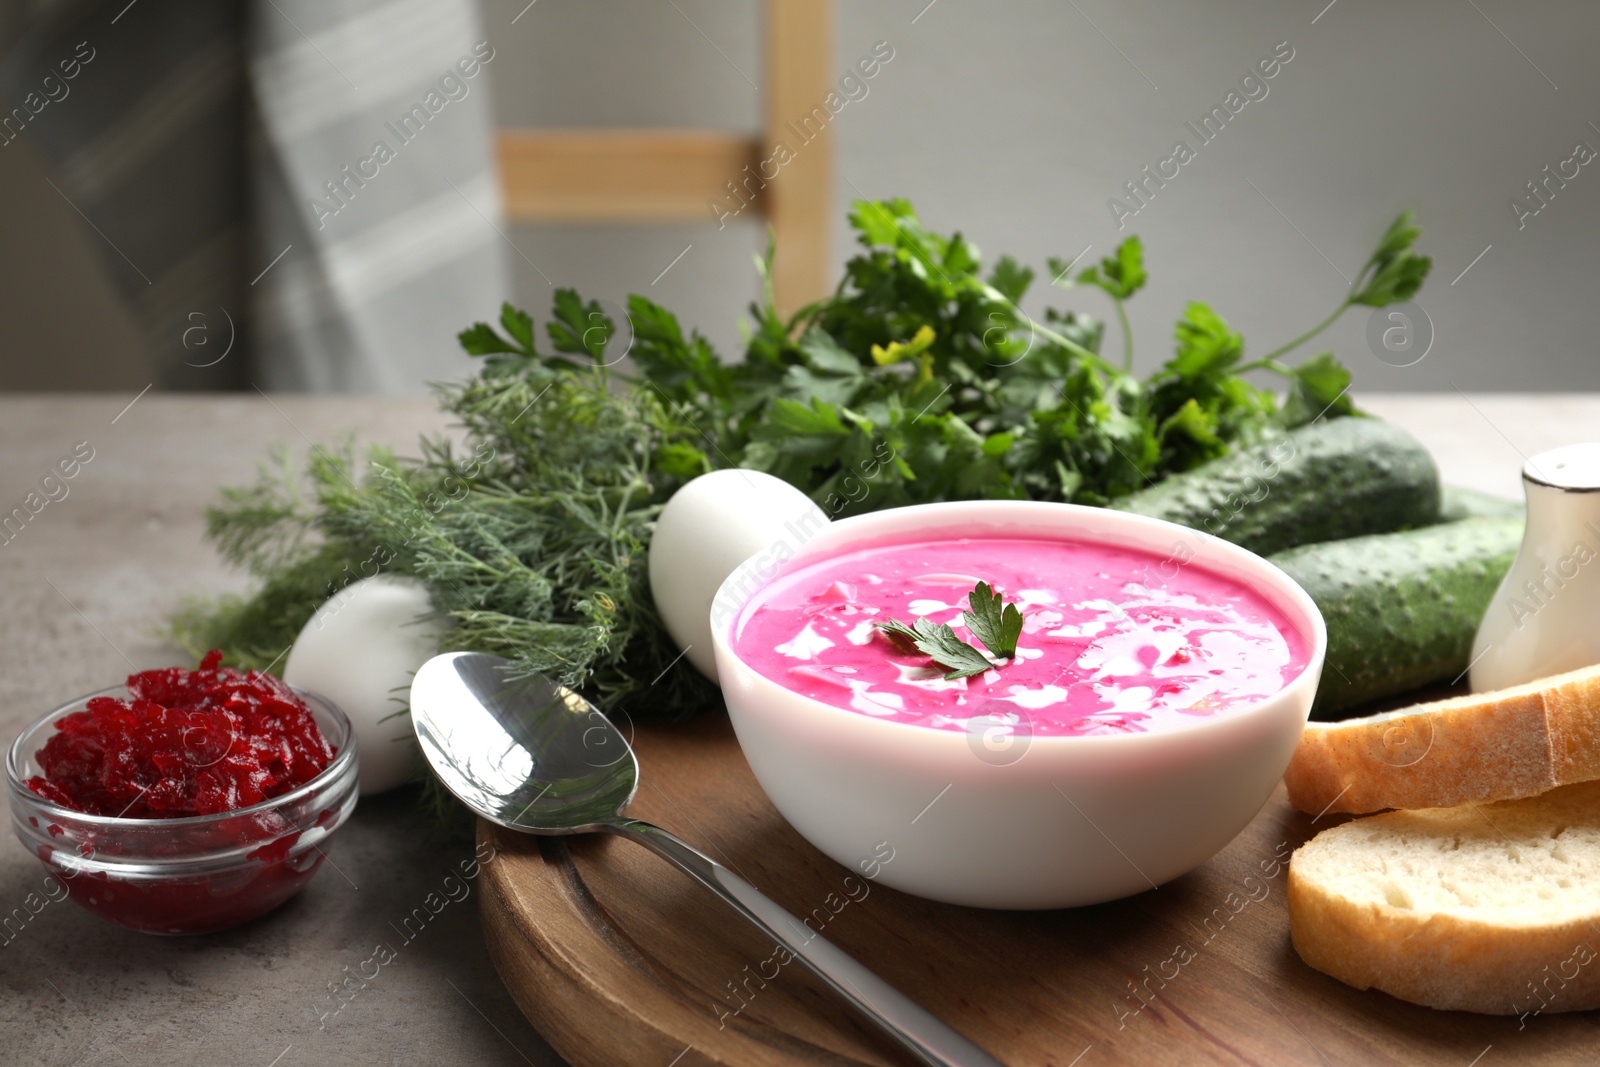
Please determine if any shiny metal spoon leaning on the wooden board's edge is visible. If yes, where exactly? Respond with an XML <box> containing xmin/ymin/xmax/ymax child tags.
<box><xmin>411</xmin><ymin>653</ymin><xmax>1002</xmax><ymax>1067</ymax></box>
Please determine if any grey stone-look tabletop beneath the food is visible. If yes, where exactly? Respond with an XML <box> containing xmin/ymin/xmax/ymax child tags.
<box><xmin>0</xmin><ymin>394</ymin><xmax>1600</xmax><ymax>1067</ymax></box>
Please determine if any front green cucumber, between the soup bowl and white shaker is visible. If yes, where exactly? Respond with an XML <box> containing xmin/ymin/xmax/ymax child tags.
<box><xmin>1270</xmin><ymin>517</ymin><xmax>1522</xmax><ymax>718</ymax></box>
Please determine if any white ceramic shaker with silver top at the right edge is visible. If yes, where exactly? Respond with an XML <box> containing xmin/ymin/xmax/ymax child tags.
<box><xmin>1470</xmin><ymin>443</ymin><xmax>1600</xmax><ymax>693</ymax></box>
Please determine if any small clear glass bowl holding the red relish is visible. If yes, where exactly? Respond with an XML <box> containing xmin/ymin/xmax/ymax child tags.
<box><xmin>5</xmin><ymin>686</ymin><xmax>358</xmax><ymax>934</ymax></box>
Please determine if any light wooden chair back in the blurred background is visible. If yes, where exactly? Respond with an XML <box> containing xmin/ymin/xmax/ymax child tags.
<box><xmin>498</xmin><ymin>0</ymin><xmax>834</xmax><ymax>321</ymax></box>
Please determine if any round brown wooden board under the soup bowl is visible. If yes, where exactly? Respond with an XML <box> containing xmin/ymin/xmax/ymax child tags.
<box><xmin>478</xmin><ymin>715</ymin><xmax>1600</xmax><ymax>1067</ymax></box>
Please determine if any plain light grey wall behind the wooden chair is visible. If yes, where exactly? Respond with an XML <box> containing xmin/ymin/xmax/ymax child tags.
<box><xmin>485</xmin><ymin>0</ymin><xmax>1600</xmax><ymax>392</ymax></box>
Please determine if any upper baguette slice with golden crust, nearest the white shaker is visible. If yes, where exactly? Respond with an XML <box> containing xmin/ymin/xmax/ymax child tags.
<box><xmin>1283</xmin><ymin>665</ymin><xmax>1600</xmax><ymax>814</ymax></box>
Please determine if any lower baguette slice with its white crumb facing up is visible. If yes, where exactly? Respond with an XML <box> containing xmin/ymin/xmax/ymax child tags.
<box><xmin>1288</xmin><ymin>782</ymin><xmax>1600</xmax><ymax>1016</ymax></box>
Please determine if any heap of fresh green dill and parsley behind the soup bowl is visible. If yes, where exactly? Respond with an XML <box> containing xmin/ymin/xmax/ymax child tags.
<box><xmin>173</xmin><ymin>200</ymin><xmax>1430</xmax><ymax>713</ymax></box>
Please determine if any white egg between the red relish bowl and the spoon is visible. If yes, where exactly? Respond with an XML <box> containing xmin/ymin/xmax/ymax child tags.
<box><xmin>283</xmin><ymin>574</ymin><xmax>450</xmax><ymax>797</ymax></box>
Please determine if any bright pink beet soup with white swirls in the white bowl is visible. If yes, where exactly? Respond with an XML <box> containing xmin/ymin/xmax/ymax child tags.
<box><xmin>733</xmin><ymin>537</ymin><xmax>1310</xmax><ymax>736</ymax></box>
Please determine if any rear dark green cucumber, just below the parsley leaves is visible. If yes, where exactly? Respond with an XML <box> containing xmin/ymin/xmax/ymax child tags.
<box><xmin>1112</xmin><ymin>418</ymin><xmax>1438</xmax><ymax>555</ymax></box>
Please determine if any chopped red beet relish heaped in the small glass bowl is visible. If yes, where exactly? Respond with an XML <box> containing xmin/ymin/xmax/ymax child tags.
<box><xmin>27</xmin><ymin>649</ymin><xmax>334</xmax><ymax>819</ymax></box>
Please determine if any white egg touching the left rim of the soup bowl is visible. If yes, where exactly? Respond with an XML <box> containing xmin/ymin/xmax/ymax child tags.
<box><xmin>650</xmin><ymin>469</ymin><xmax>827</xmax><ymax>681</ymax></box>
